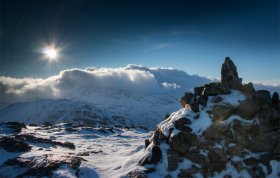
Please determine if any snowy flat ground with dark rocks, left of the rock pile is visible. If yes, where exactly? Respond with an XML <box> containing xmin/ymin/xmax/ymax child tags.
<box><xmin>0</xmin><ymin>122</ymin><xmax>148</xmax><ymax>178</ymax></box>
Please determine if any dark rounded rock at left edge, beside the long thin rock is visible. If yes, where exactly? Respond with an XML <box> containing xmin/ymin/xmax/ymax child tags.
<box><xmin>0</xmin><ymin>137</ymin><xmax>31</xmax><ymax>152</ymax></box>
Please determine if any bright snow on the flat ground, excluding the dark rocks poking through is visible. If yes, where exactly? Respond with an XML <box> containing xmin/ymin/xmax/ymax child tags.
<box><xmin>0</xmin><ymin>125</ymin><xmax>149</xmax><ymax>178</ymax></box>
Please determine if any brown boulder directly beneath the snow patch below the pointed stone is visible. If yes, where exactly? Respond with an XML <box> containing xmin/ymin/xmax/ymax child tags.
<box><xmin>212</xmin><ymin>104</ymin><xmax>234</xmax><ymax>121</ymax></box>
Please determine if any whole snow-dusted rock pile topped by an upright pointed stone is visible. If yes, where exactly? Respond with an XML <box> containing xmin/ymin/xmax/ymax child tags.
<box><xmin>133</xmin><ymin>57</ymin><xmax>280</xmax><ymax>177</ymax></box>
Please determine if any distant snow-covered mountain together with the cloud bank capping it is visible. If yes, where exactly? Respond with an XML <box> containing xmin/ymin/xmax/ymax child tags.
<box><xmin>0</xmin><ymin>65</ymin><xmax>279</xmax><ymax>129</ymax></box>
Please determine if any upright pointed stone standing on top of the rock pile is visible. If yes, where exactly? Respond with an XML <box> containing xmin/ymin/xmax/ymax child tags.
<box><xmin>221</xmin><ymin>57</ymin><xmax>242</xmax><ymax>88</ymax></box>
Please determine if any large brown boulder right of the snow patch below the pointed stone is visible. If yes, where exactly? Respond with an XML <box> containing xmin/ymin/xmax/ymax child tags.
<box><xmin>236</xmin><ymin>100</ymin><xmax>260</xmax><ymax>119</ymax></box>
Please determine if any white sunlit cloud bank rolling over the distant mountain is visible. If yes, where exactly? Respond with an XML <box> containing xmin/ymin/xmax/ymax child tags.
<box><xmin>0</xmin><ymin>65</ymin><xmax>280</xmax><ymax>108</ymax></box>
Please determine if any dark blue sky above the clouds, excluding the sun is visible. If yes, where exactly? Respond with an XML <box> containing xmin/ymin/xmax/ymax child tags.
<box><xmin>0</xmin><ymin>0</ymin><xmax>280</xmax><ymax>82</ymax></box>
